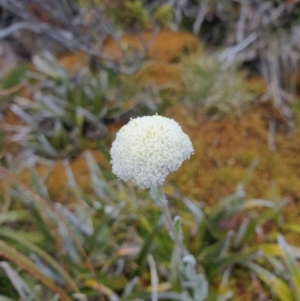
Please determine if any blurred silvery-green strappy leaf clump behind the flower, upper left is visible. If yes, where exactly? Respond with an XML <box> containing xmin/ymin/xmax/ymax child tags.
<box><xmin>5</xmin><ymin>53</ymin><xmax>157</xmax><ymax>157</ymax></box>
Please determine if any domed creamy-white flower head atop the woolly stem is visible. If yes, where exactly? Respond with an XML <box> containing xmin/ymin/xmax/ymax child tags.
<box><xmin>110</xmin><ymin>115</ymin><xmax>194</xmax><ymax>188</ymax></box>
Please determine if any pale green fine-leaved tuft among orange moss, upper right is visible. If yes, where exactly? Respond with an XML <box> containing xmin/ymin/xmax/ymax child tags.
<box><xmin>182</xmin><ymin>52</ymin><xmax>254</xmax><ymax>114</ymax></box>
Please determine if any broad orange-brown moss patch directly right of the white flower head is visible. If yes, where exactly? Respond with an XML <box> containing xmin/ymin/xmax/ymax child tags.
<box><xmin>167</xmin><ymin>106</ymin><xmax>300</xmax><ymax>211</ymax></box>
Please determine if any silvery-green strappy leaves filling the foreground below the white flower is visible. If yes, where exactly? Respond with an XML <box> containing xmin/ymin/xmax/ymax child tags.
<box><xmin>0</xmin><ymin>153</ymin><xmax>300</xmax><ymax>301</ymax></box>
